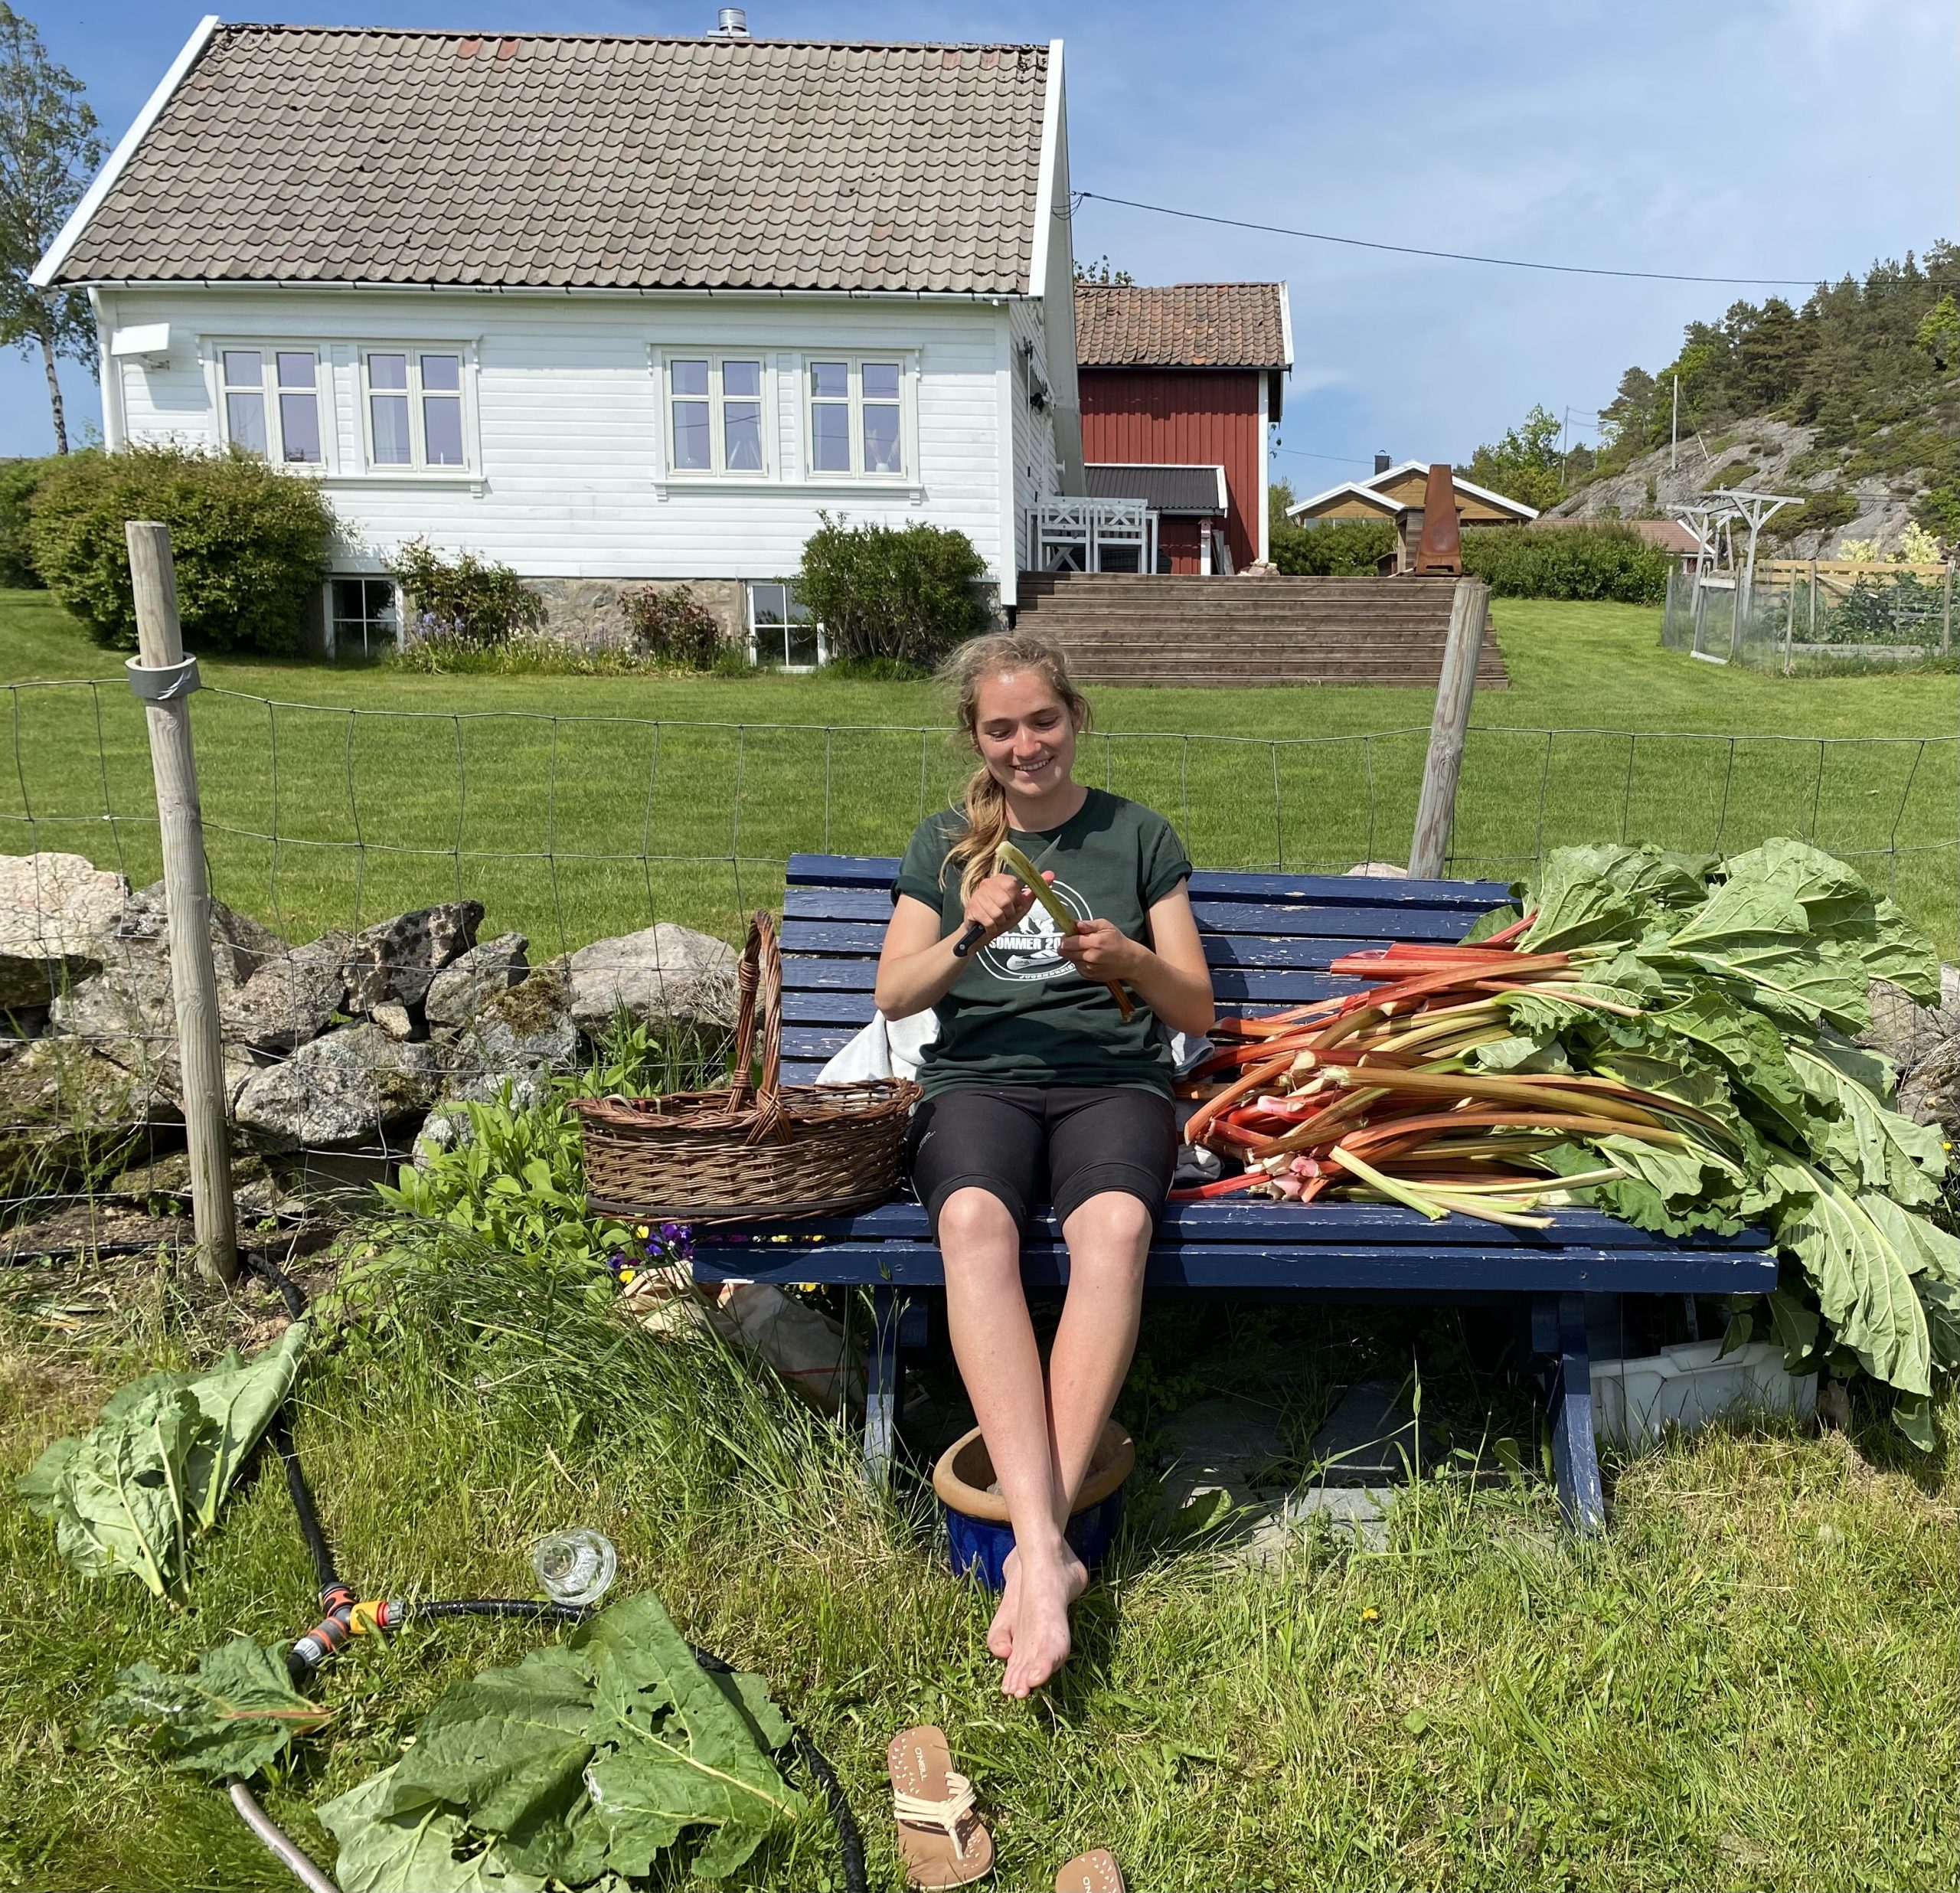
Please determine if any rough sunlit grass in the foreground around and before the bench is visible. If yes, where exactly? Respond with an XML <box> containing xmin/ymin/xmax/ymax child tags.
<box><xmin>0</xmin><ymin>1264</ymin><xmax>1960</xmax><ymax>1893</ymax></box>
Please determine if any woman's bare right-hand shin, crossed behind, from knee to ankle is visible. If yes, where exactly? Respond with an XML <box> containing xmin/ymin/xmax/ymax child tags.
<box><xmin>1049</xmin><ymin>1189</ymin><xmax>1151</xmax><ymax>1525</ymax></box>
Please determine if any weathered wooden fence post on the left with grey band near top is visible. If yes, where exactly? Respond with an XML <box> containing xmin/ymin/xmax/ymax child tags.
<box><xmin>123</xmin><ymin>519</ymin><xmax>239</xmax><ymax>1283</ymax></box>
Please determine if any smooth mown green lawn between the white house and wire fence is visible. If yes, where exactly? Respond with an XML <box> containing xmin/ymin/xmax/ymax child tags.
<box><xmin>0</xmin><ymin>592</ymin><xmax>1960</xmax><ymax>953</ymax></box>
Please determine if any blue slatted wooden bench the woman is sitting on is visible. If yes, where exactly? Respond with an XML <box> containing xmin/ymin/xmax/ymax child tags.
<box><xmin>694</xmin><ymin>855</ymin><xmax>1775</xmax><ymax>1531</ymax></box>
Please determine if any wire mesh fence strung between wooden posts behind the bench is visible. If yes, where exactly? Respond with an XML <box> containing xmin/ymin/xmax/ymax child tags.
<box><xmin>0</xmin><ymin>682</ymin><xmax>1960</xmax><ymax>1256</ymax></box>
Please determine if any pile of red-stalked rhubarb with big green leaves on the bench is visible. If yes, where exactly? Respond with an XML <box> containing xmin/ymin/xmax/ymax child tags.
<box><xmin>1180</xmin><ymin>841</ymin><xmax>1960</xmax><ymax>1447</ymax></box>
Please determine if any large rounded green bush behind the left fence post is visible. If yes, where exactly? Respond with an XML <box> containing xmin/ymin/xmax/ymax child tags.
<box><xmin>28</xmin><ymin>446</ymin><xmax>333</xmax><ymax>656</ymax></box>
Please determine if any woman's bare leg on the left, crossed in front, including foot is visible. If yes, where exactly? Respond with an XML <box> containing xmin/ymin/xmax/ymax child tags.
<box><xmin>939</xmin><ymin>1189</ymin><xmax>1086</xmax><ymax>1695</ymax></box>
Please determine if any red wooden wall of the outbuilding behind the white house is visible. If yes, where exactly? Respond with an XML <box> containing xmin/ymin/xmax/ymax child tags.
<box><xmin>1076</xmin><ymin>368</ymin><xmax>1266</xmax><ymax>572</ymax></box>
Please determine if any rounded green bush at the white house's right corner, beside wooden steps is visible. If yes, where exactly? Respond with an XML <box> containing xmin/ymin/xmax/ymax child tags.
<box><xmin>795</xmin><ymin>513</ymin><xmax>994</xmax><ymax>666</ymax></box>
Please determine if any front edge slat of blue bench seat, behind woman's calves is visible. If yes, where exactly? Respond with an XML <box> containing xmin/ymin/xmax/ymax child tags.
<box><xmin>694</xmin><ymin>1241</ymin><xmax>1775</xmax><ymax>1296</ymax></box>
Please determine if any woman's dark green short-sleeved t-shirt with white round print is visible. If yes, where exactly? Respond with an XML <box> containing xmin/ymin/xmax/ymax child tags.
<box><xmin>892</xmin><ymin>790</ymin><xmax>1191</xmax><ymax>1097</ymax></box>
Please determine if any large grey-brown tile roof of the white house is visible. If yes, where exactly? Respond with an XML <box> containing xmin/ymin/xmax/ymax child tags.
<box><xmin>57</xmin><ymin>25</ymin><xmax>1049</xmax><ymax>294</ymax></box>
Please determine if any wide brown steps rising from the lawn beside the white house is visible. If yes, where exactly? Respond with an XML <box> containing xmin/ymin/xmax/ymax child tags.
<box><xmin>1019</xmin><ymin>572</ymin><xmax>1508</xmax><ymax>690</ymax></box>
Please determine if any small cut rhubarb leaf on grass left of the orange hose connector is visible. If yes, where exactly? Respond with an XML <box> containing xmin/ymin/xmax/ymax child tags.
<box><xmin>96</xmin><ymin>1636</ymin><xmax>333</xmax><ymax>1781</ymax></box>
